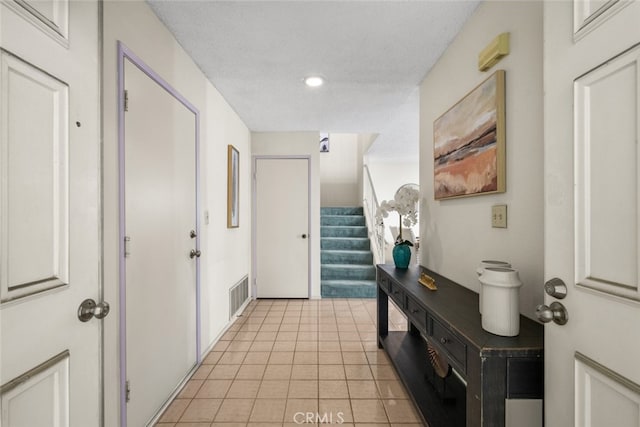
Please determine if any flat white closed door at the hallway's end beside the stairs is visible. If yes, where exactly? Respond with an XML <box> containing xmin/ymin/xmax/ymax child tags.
<box><xmin>254</xmin><ymin>158</ymin><xmax>310</xmax><ymax>298</ymax></box>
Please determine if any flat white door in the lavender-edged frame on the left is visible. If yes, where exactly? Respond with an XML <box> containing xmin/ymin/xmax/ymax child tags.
<box><xmin>124</xmin><ymin>59</ymin><xmax>197</xmax><ymax>426</ymax></box>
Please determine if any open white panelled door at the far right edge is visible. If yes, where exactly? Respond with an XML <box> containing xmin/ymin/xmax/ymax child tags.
<box><xmin>544</xmin><ymin>0</ymin><xmax>640</xmax><ymax>427</ymax></box>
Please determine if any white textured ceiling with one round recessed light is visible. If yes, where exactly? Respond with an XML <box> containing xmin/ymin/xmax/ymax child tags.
<box><xmin>147</xmin><ymin>0</ymin><xmax>478</xmax><ymax>159</ymax></box>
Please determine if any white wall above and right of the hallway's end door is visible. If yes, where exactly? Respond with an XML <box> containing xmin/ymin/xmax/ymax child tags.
<box><xmin>251</xmin><ymin>132</ymin><xmax>320</xmax><ymax>298</ymax></box>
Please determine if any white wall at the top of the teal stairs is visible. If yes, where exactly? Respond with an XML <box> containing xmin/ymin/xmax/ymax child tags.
<box><xmin>320</xmin><ymin>133</ymin><xmax>362</xmax><ymax>207</ymax></box>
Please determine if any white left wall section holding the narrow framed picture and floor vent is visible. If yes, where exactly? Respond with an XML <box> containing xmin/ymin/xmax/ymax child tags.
<box><xmin>200</xmin><ymin>82</ymin><xmax>251</xmax><ymax>349</ymax></box>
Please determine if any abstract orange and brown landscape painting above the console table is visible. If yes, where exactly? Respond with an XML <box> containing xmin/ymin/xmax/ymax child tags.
<box><xmin>433</xmin><ymin>70</ymin><xmax>506</xmax><ymax>200</ymax></box>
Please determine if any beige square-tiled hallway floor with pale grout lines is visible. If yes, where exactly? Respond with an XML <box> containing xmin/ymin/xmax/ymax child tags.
<box><xmin>156</xmin><ymin>299</ymin><xmax>422</xmax><ymax>427</ymax></box>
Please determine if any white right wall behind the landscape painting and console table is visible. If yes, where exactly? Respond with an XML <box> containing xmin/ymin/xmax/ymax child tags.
<box><xmin>420</xmin><ymin>1</ymin><xmax>543</xmax><ymax>318</ymax></box>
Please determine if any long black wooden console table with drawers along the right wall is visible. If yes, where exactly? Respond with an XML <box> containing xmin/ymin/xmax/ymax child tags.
<box><xmin>377</xmin><ymin>265</ymin><xmax>544</xmax><ymax>427</ymax></box>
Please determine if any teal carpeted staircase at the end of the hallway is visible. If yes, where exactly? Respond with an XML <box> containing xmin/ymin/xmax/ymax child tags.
<box><xmin>320</xmin><ymin>207</ymin><xmax>376</xmax><ymax>298</ymax></box>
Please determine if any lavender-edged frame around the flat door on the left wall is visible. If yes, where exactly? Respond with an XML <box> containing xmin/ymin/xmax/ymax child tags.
<box><xmin>117</xmin><ymin>41</ymin><xmax>202</xmax><ymax>427</ymax></box>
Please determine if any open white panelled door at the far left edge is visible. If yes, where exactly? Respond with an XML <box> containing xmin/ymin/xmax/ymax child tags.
<box><xmin>0</xmin><ymin>0</ymin><xmax>102</xmax><ymax>427</ymax></box>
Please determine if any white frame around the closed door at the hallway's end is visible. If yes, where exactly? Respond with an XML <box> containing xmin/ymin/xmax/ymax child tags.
<box><xmin>251</xmin><ymin>154</ymin><xmax>314</xmax><ymax>299</ymax></box>
